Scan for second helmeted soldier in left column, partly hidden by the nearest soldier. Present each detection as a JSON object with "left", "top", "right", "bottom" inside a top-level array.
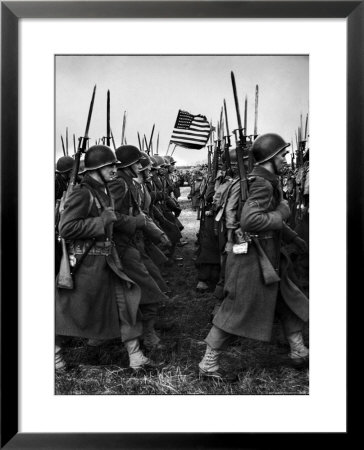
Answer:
[{"left": 110, "top": 145, "right": 169, "bottom": 350}]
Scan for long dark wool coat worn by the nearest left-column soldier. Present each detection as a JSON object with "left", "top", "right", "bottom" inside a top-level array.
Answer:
[{"left": 56, "top": 175, "right": 140, "bottom": 339}]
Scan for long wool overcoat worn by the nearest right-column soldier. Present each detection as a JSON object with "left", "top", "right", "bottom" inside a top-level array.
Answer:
[{"left": 213, "top": 166, "right": 308, "bottom": 341}]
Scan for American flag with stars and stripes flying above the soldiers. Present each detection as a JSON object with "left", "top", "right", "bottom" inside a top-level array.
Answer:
[{"left": 171, "top": 110, "right": 211, "bottom": 150}]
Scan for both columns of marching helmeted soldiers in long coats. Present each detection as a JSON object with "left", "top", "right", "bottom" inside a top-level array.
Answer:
[{"left": 55, "top": 133, "right": 309, "bottom": 381}]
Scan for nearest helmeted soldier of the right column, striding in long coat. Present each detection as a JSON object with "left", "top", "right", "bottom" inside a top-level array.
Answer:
[{"left": 199, "top": 133, "right": 308, "bottom": 381}]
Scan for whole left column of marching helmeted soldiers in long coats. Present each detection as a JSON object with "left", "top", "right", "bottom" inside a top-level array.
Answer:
[{"left": 55, "top": 145, "right": 186, "bottom": 370}]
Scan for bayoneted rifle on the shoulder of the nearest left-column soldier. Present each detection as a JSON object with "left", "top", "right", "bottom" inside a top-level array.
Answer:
[{"left": 57, "top": 85, "right": 96, "bottom": 289}]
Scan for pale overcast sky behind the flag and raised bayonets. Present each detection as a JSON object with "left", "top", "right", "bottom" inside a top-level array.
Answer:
[{"left": 55, "top": 55, "right": 309, "bottom": 165}]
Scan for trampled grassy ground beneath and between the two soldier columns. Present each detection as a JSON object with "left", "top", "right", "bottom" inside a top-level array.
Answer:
[{"left": 55, "top": 187, "right": 309, "bottom": 395}]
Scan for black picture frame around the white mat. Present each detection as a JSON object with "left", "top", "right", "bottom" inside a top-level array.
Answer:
[{"left": 0, "top": 0, "right": 358, "bottom": 449}]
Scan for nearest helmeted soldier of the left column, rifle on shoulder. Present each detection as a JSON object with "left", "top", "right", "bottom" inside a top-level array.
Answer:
[{"left": 56, "top": 145, "right": 154, "bottom": 370}]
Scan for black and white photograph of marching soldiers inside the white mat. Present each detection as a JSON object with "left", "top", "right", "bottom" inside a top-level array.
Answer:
[{"left": 54, "top": 54, "right": 315, "bottom": 396}]
